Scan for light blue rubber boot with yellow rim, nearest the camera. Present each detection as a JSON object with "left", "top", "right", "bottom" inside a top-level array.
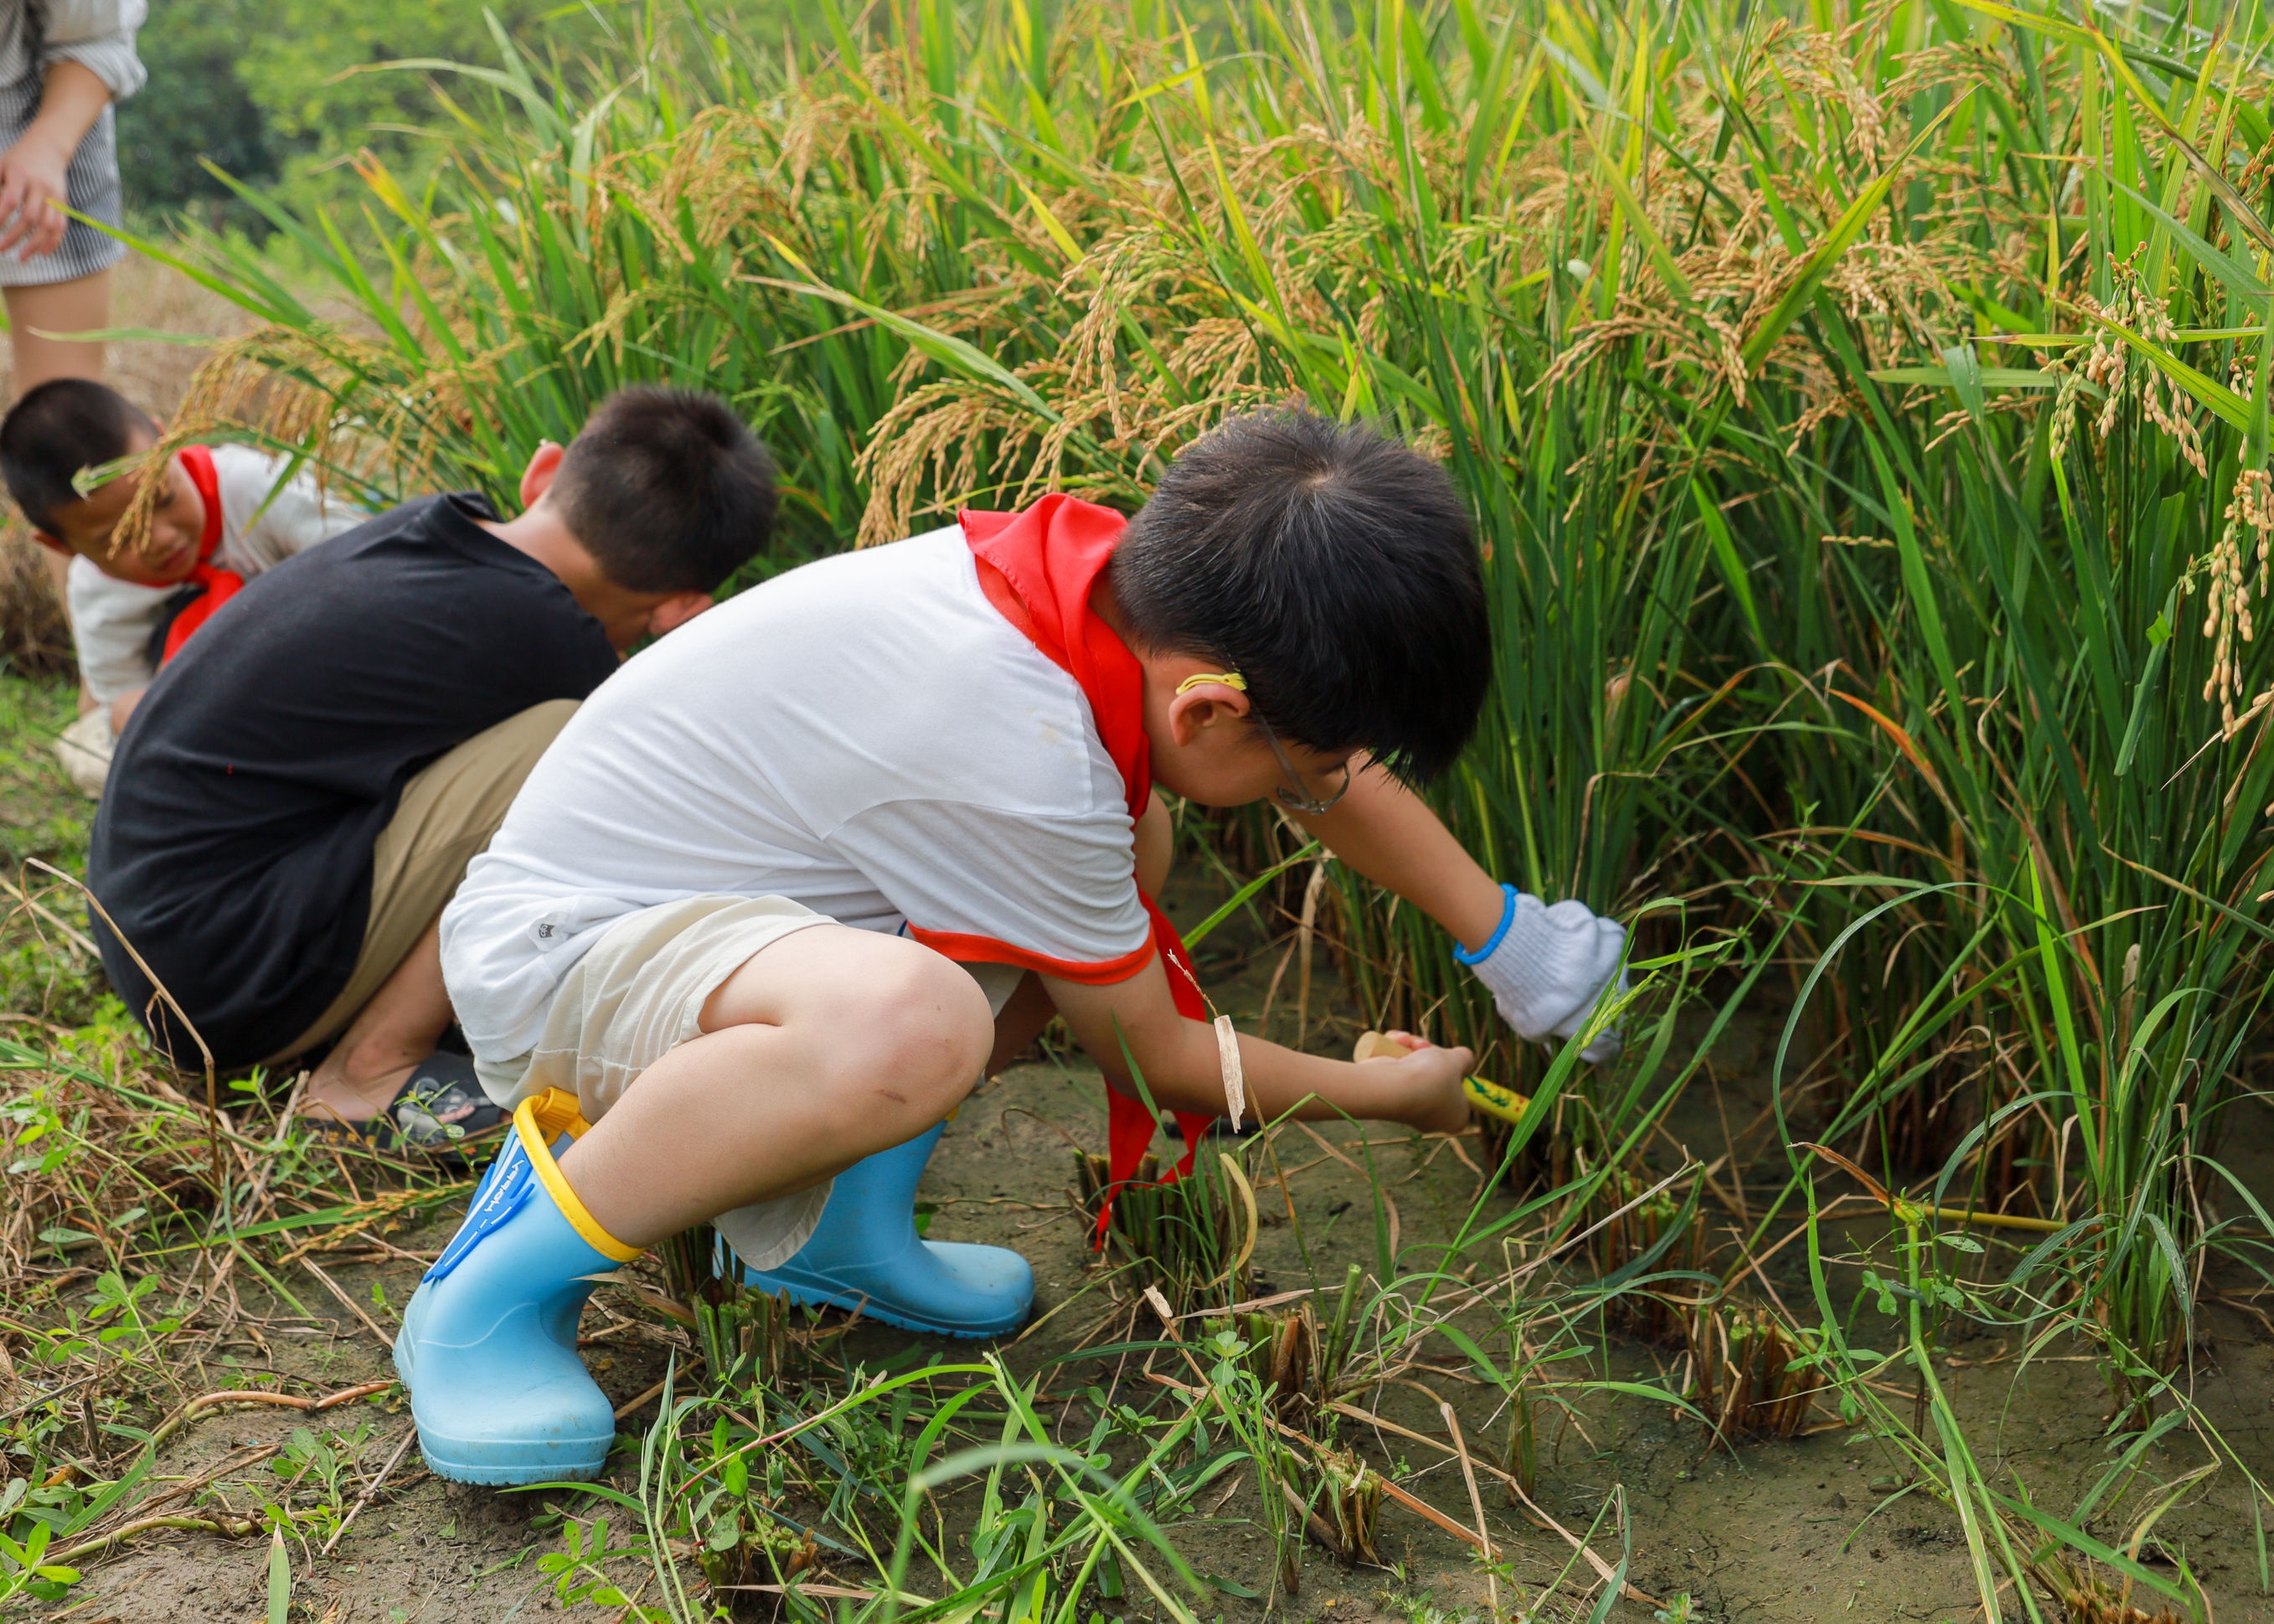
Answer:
[{"left": 395, "top": 1090, "right": 639, "bottom": 1483}]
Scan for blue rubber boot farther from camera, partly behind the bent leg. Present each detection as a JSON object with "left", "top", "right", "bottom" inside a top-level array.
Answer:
[{"left": 744, "top": 1124, "right": 1034, "bottom": 1338}]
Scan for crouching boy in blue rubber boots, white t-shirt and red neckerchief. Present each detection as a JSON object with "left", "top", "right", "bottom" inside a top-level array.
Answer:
[{"left": 395, "top": 412, "right": 1624, "bottom": 1483}]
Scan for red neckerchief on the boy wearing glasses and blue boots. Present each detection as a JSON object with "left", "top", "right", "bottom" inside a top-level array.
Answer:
[{"left": 957, "top": 496, "right": 1214, "bottom": 1246}]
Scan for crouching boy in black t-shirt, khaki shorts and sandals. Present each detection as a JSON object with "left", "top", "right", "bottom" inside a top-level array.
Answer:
[{"left": 86, "top": 389, "right": 773, "bottom": 1148}]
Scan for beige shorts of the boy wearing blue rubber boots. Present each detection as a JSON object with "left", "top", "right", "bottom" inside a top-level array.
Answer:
[{"left": 475, "top": 896, "right": 834, "bottom": 1269}]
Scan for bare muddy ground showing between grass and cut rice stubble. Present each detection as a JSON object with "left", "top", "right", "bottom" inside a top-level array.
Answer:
[{"left": 26, "top": 878, "right": 2274, "bottom": 1624}]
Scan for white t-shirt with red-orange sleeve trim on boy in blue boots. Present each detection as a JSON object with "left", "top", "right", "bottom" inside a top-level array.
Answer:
[{"left": 441, "top": 530, "right": 1153, "bottom": 1062}]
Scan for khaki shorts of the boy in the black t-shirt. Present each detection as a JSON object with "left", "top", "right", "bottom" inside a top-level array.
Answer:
[{"left": 261, "top": 699, "right": 575, "bottom": 1065}]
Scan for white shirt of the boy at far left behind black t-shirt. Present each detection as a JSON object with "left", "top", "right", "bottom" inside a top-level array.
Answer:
[{"left": 66, "top": 446, "right": 371, "bottom": 705}]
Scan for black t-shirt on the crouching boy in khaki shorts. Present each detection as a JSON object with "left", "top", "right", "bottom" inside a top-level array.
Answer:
[{"left": 86, "top": 496, "right": 616, "bottom": 1067}]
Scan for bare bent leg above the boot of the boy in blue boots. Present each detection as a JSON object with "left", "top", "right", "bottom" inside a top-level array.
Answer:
[{"left": 562, "top": 925, "right": 993, "bottom": 1246}]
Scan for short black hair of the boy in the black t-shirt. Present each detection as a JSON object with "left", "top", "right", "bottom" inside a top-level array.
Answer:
[{"left": 548, "top": 387, "right": 773, "bottom": 591}]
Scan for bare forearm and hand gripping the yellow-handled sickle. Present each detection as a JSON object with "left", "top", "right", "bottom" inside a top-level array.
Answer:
[{"left": 1041, "top": 956, "right": 1476, "bottom": 1132}]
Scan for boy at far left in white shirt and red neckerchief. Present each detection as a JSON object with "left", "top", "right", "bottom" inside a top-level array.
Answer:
[{"left": 0, "top": 378, "right": 369, "bottom": 794}]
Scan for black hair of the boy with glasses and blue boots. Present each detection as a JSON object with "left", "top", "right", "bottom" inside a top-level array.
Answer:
[{"left": 1112, "top": 407, "right": 1492, "bottom": 782}]
